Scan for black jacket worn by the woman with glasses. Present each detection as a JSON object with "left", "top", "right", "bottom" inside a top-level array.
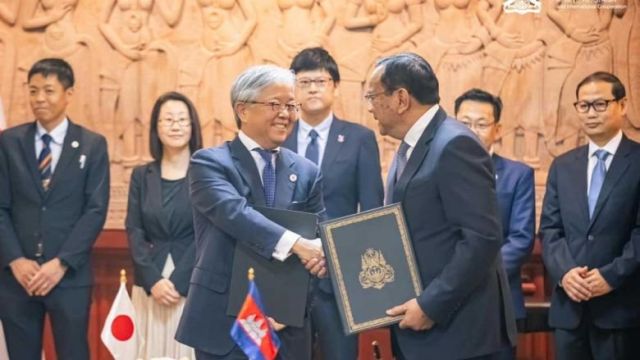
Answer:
[{"left": 126, "top": 162, "right": 195, "bottom": 296}]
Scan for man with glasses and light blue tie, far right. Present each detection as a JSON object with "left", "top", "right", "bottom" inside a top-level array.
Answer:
[{"left": 540, "top": 72, "right": 640, "bottom": 360}]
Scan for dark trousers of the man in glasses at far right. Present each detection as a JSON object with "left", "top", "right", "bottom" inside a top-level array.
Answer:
[{"left": 554, "top": 305, "right": 640, "bottom": 360}]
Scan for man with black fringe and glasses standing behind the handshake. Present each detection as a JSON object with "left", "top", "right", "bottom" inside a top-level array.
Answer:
[{"left": 283, "top": 48, "right": 383, "bottom": 360}]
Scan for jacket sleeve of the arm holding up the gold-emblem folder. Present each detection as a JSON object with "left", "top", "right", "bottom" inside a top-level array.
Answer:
[{"left": 418, "top": 136, "right": 502, "bottom": 326}]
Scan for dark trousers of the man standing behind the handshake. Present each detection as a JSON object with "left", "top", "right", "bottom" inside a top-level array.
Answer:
[{"left": 311, "top": 289, "right": 358, "bottom": 360}]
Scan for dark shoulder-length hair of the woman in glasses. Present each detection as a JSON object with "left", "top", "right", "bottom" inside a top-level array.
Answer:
[{"left": 149, "top": 91, "right": 202, "bottom": 161}]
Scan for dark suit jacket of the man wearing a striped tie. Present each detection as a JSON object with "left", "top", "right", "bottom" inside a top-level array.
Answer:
[{"left": 0, "top": 121, "right": 109, "bottom": 287}]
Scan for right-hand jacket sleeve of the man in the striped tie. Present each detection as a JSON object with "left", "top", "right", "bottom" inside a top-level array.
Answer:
[{"left": 58, "top": 136, "right": 109, "bottom": 270}]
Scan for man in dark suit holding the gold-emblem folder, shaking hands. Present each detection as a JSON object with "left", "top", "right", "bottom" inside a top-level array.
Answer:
[{"left": 365, "top": 53, "right": 515, "bottom": 359}]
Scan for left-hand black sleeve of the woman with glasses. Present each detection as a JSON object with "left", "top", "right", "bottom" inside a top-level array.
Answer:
[{"left": 125, "top": 167, "right": 162, "bottom": 293}]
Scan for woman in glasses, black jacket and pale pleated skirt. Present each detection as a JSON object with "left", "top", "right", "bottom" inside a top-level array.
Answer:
[{"left": 126, "top": 92, "right": 202, "bottom": 359}]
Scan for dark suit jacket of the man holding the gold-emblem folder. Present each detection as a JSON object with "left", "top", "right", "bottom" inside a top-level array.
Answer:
[{"left": 389, "top": 109, "right": 516, "bottom": 359}]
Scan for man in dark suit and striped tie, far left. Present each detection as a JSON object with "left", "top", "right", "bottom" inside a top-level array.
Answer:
[{"left": 0, "top": 59, "right": 109, "bottom": 359}]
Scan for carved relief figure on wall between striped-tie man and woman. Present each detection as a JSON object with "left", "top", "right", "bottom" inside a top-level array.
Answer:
[{"left": 98, "top": 0, "right": 184, "bottom": 168}]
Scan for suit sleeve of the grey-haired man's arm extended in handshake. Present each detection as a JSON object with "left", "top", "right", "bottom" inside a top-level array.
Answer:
[{"left": 189, "top": 150, "right": 285, "bottom": 259}]
